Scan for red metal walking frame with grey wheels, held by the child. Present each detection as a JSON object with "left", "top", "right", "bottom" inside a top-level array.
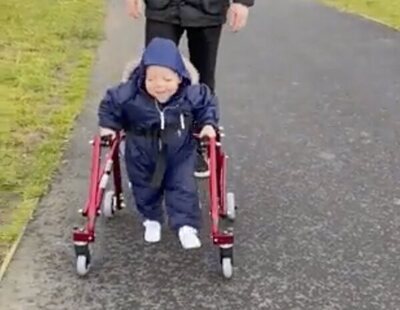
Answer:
[{"left": 73, "top": 128, "right": 236, "bottom": 278}]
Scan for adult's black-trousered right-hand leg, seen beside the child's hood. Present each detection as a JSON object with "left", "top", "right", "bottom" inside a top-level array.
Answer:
[{"left": 186, "top": 26, "right": 222, "bottom": 91}]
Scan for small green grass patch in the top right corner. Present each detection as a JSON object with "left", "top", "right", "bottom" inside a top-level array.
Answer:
[{"left": 321, "top": 0, "right": 400, "bottom": 30}]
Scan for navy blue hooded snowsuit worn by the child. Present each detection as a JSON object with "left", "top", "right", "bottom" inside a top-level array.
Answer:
[{"left": 98, "top": 38, "right": 219, "bottom": 230}]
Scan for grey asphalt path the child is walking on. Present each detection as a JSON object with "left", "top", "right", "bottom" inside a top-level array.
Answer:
[{"left": 0, "top": 0, "right": 400, "bottom": 310}]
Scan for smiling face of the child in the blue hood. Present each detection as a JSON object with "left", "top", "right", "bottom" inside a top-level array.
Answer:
[{"left": 145, "top": 66, "right": 181, "bottom": 103}]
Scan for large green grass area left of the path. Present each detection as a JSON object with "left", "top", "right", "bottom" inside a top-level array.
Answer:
[{"left": 0, "top": 0, "right": 105, "bottom": 261}]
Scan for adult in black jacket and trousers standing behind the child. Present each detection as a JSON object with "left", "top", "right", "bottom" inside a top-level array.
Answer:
[{"left": 126, "top": 0, "right": 254, "bottom": 177}]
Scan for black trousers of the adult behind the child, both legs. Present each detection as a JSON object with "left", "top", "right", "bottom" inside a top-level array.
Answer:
[{"left": 145, "top": 19, "right": 222, "bottom": 91}]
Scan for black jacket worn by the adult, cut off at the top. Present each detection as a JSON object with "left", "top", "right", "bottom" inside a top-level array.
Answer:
[{"left": 144, "top": 0, "right": 254, "bottom": 27}]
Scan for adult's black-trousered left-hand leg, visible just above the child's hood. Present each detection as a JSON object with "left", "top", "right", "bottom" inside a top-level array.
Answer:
[{"left": 145, "top": 19, "right": 184, "bottom": 46}]
